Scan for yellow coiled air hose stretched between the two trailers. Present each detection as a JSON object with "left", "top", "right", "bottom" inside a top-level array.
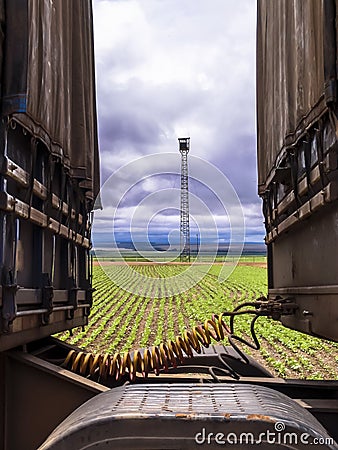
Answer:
[{"left": 62, "top": 297, "right": 268, "bottom": 381}]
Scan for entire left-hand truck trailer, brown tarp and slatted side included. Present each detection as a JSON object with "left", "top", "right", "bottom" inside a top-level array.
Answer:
[{"left": 0, "top": 0, "right": 99, "bottom": 351}]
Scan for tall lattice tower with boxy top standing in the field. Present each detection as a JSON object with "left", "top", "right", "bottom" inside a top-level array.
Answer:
[{"left": 178, "top": 138, "right": 190, "bottom": 262}]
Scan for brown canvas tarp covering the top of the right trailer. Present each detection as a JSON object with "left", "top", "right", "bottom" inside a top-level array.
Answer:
[{"left": 256, "top": 0, "right": 328, "bottom": 192}]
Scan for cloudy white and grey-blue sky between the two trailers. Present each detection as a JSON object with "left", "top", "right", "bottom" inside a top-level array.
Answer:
[{"left": 93, "top": 0, "right": 264, "bottom": 246}]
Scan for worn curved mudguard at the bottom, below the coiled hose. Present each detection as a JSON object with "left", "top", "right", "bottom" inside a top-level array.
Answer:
[{"left": 40, "top": 384, "right": 336, "bottom": 450}]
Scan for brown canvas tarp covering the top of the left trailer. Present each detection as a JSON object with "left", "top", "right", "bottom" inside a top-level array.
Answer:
[{"left": 0, "top": 0, "right": 99, "bottom": 203}]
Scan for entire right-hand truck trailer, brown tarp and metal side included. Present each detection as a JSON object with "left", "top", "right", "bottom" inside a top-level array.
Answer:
[{"left": 257, "top": 0, "right": 338, "bottom": 340}]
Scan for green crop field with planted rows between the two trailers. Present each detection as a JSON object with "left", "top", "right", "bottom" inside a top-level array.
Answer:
[{"left": 60, "top": 259, "right": 338, "bottom": 379}]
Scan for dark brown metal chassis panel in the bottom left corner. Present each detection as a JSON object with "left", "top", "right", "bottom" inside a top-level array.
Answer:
[{"left": 0, "top": 351, "right": 108, "bottom": 450}]
